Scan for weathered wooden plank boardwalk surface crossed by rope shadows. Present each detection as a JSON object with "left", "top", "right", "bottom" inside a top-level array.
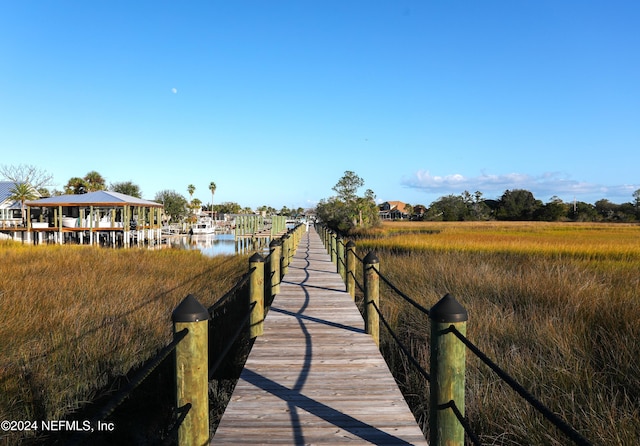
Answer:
[{"left": 211, "top": 228, "right": 427, "bottom": 445}]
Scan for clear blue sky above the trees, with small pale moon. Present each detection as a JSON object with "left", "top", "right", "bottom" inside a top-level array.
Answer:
[{"left": 0, "top": 0, "right": 640, "bottom": 209}]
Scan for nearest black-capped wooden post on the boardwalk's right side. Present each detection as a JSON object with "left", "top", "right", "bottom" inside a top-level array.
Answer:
[{"left": 429, "top": 294, "right": 468, "bottom": 446}]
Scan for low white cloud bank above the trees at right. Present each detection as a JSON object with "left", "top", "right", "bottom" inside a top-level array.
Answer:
[{"left": 402, "top": 170, "right": 640, "bottom": 201}]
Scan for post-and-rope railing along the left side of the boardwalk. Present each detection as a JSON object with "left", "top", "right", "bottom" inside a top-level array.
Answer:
[{"left": 69, "top": 225, "right": 304, "bottom": 446}]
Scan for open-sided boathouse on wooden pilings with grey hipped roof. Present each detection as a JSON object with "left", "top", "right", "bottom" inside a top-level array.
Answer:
[{"left": 25, "top": 191, "right": 163, "bottom": 246}]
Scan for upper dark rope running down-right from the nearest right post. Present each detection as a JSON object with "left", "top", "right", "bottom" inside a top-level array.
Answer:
[{"left": 449, "top": 325, "right": 591, "bottom": 446}]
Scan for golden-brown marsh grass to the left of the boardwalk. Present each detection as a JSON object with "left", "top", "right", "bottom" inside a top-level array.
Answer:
[{"left": 0, "top": 242, "right": 248, "bottom": 442}]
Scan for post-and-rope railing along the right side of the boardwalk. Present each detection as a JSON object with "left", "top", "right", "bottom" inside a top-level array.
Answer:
[{"left": 316, "top": 224, "right": 591, "bottom": 446}]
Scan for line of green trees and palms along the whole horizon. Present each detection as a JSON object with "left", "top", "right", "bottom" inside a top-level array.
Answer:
[{"left": 6, "top": 165, "right": 640, "bottom": 226}]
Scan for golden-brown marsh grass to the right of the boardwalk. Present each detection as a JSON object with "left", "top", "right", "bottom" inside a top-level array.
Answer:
[{"left": 355, "top": 222, "right": 640, "bottom": 445}]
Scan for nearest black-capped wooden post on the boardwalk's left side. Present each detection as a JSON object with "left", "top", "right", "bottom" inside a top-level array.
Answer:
[{"left": 171, "top": 294, "right": 209, "bottom": 446}]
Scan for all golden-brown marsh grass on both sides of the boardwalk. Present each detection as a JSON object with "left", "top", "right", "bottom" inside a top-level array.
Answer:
[{"left": 0, "top": 222, "right": 640, "bottom": 445}]
